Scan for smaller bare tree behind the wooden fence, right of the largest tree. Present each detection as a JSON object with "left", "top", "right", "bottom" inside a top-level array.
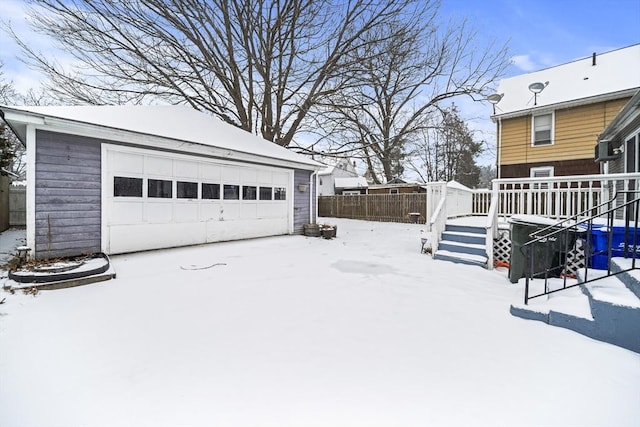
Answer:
[{"left": 306, "top": 0, "right": 508, "bottom": 183}]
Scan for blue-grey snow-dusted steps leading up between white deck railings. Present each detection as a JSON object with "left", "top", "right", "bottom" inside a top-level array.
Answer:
[{"left": 433, "top": 223, "right": 487, "bottom": 267}]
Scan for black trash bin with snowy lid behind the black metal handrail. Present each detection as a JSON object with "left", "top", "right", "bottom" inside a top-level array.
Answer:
[{"left": 509, "top": 217, "right": 576, "bottom": 283}]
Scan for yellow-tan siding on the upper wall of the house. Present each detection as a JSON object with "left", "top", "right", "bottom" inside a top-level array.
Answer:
[{"left": 500, "top": 98, "right": 629, "bottom": 165}]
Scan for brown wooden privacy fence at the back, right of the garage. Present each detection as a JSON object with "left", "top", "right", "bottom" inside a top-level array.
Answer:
[{"left": 318, "top": 193, "right": 427, "bottom": 224}]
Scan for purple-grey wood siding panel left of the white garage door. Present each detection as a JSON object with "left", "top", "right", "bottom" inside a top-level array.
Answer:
[{"left": 35, "top": 130, "right": 101, "bottom": 258}]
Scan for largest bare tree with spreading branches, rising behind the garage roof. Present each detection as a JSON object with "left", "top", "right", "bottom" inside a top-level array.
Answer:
[{"left": 8, "top": 0, "right": 421, "bottom": 146}]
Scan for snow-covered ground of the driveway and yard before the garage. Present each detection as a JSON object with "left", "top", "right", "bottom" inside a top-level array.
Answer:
[{"left": 0, "top": 219, "right": 640, "bottom": 427}]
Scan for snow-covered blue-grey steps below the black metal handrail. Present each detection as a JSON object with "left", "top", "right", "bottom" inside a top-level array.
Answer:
[{"left": 511, "top": 258, "right": 640, "bottom": 353}]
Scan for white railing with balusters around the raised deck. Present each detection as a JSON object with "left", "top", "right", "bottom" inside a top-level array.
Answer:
[{"left": 427, "top": 173, "right": 640, "bottom": 269}]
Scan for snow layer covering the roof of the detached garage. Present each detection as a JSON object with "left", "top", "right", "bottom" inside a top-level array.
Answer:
[{"left": 2, "top": 105, "right": 322, "bottom": 169}]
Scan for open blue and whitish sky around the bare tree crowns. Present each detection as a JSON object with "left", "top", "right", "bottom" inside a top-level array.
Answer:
[{"left": 0, "top": 0, "right": 640, "bottom": 169}]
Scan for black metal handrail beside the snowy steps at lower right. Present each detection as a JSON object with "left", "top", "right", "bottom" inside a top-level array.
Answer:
[{"left": 519, "top": 190, "right": 640, "bottom": 305}]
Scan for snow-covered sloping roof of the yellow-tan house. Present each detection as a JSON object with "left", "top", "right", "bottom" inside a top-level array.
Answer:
[{"left": 496, "top": 44, "right": 640, "bottom": 117}]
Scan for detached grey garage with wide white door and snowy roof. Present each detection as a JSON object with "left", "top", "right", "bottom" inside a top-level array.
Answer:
[{"left": 0, "top": 106, "right": 324, "bottom": 258}]
